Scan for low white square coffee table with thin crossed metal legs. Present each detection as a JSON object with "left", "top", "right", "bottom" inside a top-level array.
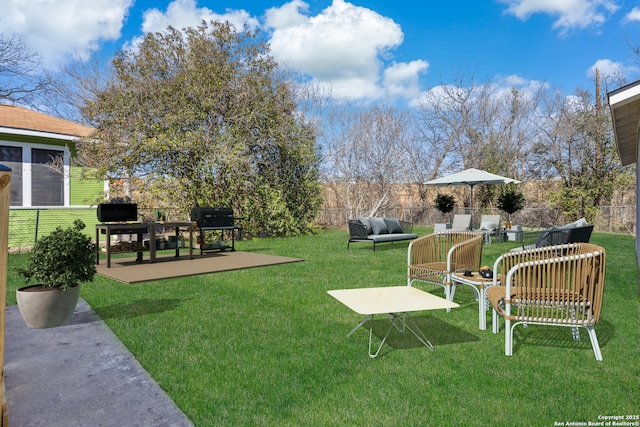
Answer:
[{"left": 327, "top": 286, "right": 459, "bottom": 358}]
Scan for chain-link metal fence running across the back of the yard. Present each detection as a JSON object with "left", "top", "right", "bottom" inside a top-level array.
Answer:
[{"left": 9, "top": 206, "right": 636, "bottom": 252}]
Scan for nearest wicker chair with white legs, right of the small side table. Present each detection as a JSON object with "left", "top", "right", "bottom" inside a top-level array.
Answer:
[{"left": 487, "top": 243, "right": 606, "bottom": 361}]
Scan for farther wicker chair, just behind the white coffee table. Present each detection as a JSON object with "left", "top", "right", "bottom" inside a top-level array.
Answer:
[{"left": 407, "top": 230, "right": 484, "bottom": 308}]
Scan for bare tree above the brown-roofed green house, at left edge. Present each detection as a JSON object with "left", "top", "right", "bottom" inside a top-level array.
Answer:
[{"left": 0, "top": 33, "right": 54, "bottom": 107}]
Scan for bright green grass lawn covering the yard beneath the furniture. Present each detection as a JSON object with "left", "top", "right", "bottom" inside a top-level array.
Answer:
[{"left": 8, "top": 228, "right": 640, "bottom": 426}]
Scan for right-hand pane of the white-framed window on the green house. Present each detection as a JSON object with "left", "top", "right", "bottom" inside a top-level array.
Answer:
[{"left": 31, "top": 148, "right": 64, "bottom": 206}]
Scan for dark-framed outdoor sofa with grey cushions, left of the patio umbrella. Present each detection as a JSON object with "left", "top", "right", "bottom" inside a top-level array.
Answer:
[{"left": 347, "top": 216, "right": 418, "bottom": 252}]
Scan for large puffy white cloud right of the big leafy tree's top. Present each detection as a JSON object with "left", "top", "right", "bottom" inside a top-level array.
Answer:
[{"left": 265, "top": 0, "right": 428, "bottom": 99}]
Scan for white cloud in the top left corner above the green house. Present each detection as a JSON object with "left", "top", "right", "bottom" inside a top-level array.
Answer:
[{"left": 0, "top": 0, "right": 133, "bottom": 69}]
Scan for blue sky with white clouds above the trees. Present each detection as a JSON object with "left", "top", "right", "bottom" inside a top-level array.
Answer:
[{"left": 0, "top": 0, "right": 640, "bottom": 105}]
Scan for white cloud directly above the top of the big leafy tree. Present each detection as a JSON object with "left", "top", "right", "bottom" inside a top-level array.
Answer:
[{"left": 142, "top": 0, "right": 258, "bottom": 34}]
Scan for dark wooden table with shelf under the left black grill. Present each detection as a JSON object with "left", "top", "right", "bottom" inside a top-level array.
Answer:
[{"left": 96, "top": 222, "right": 193, "bottom": 268}]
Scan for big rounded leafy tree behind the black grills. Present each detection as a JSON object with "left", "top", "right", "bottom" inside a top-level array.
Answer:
[{"left": 79, "top": 22, "right": 321, "bottom": 235}]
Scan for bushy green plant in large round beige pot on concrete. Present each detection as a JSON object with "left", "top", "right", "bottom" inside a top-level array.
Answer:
[{"left": 16, "top": 219, "right": 96, "bottom": 328}]
